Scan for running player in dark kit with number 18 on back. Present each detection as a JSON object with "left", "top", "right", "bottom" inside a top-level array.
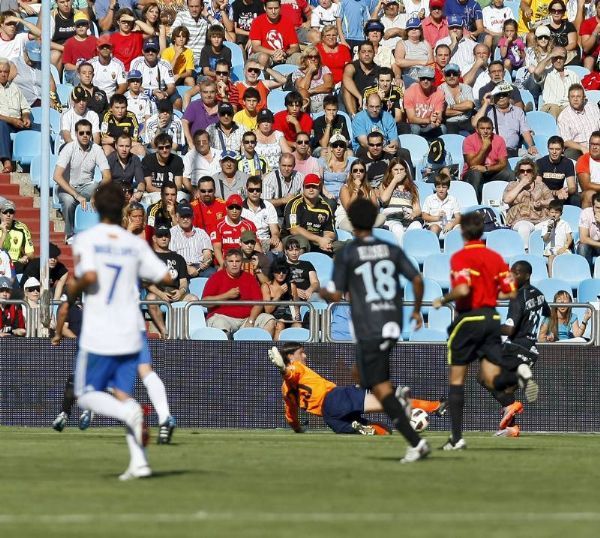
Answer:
[{"left": 320, "top": 198, "right": 431, "bottom": 463}]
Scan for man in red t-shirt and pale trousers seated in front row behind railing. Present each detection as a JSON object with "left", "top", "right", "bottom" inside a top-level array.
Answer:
[{"left": 202, "top": 248, "right": 276, "bottom": 336}]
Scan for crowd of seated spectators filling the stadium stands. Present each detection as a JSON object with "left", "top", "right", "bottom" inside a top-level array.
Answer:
[{"left": 0, "top": 0, "right": 600, "bottom": 338}]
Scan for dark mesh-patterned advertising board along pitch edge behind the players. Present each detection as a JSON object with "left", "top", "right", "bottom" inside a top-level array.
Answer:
[{"left": 0, "top": 340, "right": 600, "bottom": 435}]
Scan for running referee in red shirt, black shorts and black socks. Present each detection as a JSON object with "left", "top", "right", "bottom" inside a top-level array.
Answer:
[{"left": 433, "top": 212, "right": 537, "bottom": 450}]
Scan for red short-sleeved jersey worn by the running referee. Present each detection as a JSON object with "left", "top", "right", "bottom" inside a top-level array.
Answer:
[{"left": 450, "top": 241, "right": 516, "bottom": 312}]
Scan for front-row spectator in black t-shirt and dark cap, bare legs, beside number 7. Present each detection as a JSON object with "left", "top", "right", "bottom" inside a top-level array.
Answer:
[{"left": 146, "top": 225, "right": 198, "bottom": 338}]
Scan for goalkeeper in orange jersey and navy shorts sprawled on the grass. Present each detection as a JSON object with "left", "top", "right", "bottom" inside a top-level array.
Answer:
[{"left": 269, "top": 342, "right": 446, "bottom": 435}]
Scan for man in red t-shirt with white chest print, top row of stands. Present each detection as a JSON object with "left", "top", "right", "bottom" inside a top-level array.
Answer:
[{"left": 249, "top": 0, "right": 300, "bottom": 66}]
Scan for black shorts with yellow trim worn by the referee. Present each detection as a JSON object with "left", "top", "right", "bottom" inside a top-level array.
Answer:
[{"left": 448, "top": 308, "right": 502, "bottom": 366}]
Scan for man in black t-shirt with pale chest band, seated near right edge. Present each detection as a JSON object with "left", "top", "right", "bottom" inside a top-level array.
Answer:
[{"left": 536, "top": 135, "right": 581, "bottom": 207}]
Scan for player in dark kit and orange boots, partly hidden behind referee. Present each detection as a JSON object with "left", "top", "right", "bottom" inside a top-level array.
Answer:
[{"left": 492, "top": 260, "right": 550, "bottom": 437}]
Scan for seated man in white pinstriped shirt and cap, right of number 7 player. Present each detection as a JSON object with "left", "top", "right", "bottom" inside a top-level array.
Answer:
[{"left": 169, "top": 202, "right": 215, "bottom": 278}]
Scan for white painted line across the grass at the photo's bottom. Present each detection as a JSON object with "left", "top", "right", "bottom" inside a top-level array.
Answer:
[{"left": 0, "top": 511, "right": 600, "bottom": 525}]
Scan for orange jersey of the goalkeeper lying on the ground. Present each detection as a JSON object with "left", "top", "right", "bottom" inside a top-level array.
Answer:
[{"left": 281, "top": 362, "right": 336, "bottom": 427}]
